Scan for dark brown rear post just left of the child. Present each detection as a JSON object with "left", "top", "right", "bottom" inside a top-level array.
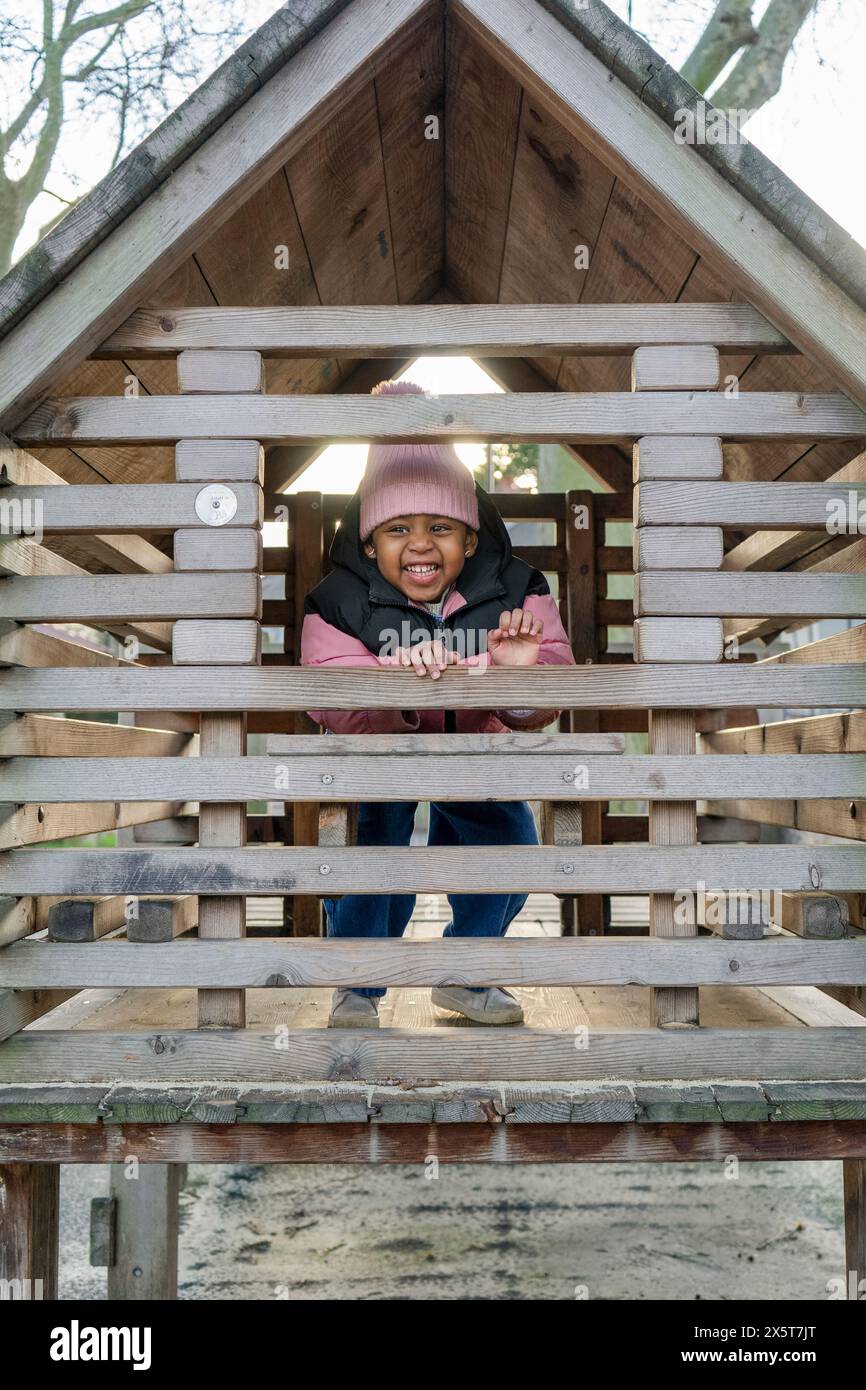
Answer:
[{"left": 289, "top": 492, "right": 324, "bottom": 937}]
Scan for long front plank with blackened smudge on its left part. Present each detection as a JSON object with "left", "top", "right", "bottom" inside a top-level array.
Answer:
[{"left": 0, "top": 845, "right": 866, "bottom": 897}]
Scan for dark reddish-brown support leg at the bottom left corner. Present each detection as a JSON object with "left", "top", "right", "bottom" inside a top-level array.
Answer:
[{"left": 0, "top": 1163, "right": 60, "bottom": 1300}]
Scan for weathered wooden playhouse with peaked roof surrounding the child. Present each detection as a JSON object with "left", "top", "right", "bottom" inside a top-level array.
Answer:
[{"left": 0, "top": 0, "right": 866, "bottom": 1298}]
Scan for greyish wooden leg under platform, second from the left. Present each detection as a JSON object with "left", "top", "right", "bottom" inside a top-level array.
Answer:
[{"left": 108, "top": 1163, "right": 179, "bottom": 1302}]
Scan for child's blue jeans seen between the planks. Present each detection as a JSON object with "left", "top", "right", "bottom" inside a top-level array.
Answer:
[{"left": 322, "top": 801, "right": 538, "bottom": 997}]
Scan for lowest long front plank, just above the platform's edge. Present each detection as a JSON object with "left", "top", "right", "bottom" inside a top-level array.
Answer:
[{"left": 0, "top": 1027, "right": 866, "bottom": 1083}]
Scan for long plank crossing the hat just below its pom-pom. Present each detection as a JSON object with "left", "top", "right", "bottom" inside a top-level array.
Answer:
[{"left": 15, "top": 391, "right": 866, "bottom": 444}]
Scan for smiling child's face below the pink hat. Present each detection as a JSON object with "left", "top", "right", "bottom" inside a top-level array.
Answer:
[{"left": 364, "top": 513, "right": 478, "bottom": 602}]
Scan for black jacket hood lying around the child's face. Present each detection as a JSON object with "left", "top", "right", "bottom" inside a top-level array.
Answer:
[{"left": 328, "top": 482, "right": 512, "bottom": 603}]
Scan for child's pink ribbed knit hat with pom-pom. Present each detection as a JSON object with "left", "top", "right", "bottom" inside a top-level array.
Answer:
[{"left": 359, "top": 381, "right": 478, "bottom": 541}]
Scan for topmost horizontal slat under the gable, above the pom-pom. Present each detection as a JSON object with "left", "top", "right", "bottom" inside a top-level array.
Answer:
[{"left": 90, "top": 303, "right": 792, "bottom": 359}]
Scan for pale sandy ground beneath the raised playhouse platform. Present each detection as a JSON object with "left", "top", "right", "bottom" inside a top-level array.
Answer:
[{"left": 60, "top": 1162, "right": 844, "bottom": 1301}]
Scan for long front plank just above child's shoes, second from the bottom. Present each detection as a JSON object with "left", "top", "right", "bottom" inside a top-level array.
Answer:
[{"left": 0, "top": 934, "right": 866, "bottom": 990}]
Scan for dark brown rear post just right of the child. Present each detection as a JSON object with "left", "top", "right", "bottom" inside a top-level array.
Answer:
[{"left": 563, "top": 489, "right": 605, "bottom": 937}]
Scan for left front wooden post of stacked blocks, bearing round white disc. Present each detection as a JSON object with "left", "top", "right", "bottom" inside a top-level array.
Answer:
[{"left": 172, "top": 350, "right": 264, "bottom": 1029}]
